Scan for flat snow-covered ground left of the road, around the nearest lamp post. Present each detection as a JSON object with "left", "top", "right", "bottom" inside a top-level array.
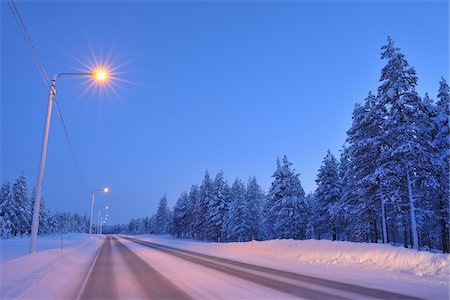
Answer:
[{"left": 0, "top": 234, "right": 103, "bottom": 299}]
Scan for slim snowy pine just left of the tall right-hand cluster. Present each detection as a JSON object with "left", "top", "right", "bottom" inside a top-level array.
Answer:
[{"left": 315, "top": 150, "right": 341, "bottom": 241}]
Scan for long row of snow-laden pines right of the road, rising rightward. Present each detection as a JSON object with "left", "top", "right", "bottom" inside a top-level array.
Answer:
[{"left": 118, "top": 37, "right": 450, "bottom": 253}]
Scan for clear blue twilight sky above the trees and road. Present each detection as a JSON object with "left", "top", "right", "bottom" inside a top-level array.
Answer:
[{"left": 1, "top": 1, "right": 449, "bottom": 223}]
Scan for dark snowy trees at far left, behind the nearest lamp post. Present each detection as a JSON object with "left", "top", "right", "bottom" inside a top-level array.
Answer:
[{"left": 0, "top": 176, "right": 89, "bottom": 238}]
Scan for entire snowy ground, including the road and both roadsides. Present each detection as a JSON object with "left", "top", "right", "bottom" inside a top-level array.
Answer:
[{"left": 0, "top": 235, "right": 449, "bottom": 299}]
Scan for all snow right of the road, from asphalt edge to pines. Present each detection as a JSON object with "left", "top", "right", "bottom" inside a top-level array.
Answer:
[{"left": 133, "top": 235, "right": 450, "bottom": 299}]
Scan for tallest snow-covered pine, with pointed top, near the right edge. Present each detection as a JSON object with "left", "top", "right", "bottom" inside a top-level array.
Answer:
[{"left": 378, "top": 38, "right": 433, "bottom": 249}]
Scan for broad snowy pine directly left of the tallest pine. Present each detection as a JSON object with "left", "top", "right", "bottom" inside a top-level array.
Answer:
[{"left": 340, "top": 92, "right": 387, "bottom": 243}]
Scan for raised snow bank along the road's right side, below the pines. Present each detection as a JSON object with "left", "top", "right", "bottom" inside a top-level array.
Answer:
[{"left": 139, "top": 235, "right": 450, "bottom": 278}]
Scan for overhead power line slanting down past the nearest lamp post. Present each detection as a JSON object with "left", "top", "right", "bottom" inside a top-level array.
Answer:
[{"left": 8, "top": 0, "right": 92, "bottom": 191}]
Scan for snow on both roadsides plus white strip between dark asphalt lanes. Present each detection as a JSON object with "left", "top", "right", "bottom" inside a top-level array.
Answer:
[{"left": 0, "top": 234, "right": 450, "bottom": 299}]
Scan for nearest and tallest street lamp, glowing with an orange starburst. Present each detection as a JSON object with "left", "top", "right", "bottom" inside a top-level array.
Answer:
[{"left": 30, "top": 69, "right": 108, "bottom": 253}]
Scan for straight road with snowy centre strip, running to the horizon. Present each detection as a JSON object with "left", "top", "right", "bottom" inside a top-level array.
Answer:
[{"left": 78, "top": 235, "right": 414, "bottom": 299}]
